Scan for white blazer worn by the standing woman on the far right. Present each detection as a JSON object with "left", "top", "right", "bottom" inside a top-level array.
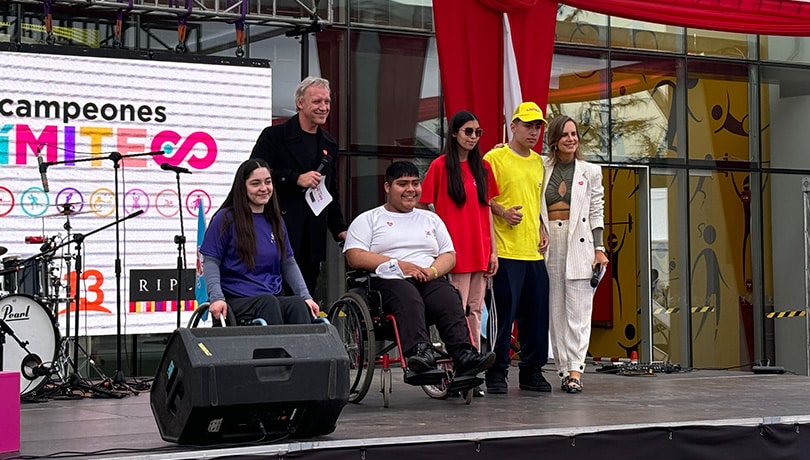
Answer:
[{"left": 540, "top": 155, "right": 605, "bottom": 279}]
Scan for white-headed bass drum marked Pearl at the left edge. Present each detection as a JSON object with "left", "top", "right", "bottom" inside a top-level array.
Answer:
[{"left": 0, "top": 294, "right": 59, "bottom": 396}]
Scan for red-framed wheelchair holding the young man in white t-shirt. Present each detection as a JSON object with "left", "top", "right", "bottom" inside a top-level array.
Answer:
[{"left": 327, "top": 271, "right": 483, "bottom": 408}]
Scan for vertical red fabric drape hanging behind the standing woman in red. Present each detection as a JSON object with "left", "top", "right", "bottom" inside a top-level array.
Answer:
[{"left": 433, "top": 0, "right": 557, "bottom": 147}]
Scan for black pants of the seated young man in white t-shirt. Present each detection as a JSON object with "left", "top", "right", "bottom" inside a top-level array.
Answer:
[{"left": 371, "top": 278, "right": 472, "bottom": 357}]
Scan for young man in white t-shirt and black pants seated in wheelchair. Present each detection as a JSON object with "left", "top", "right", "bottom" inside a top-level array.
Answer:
[{"left": 343, "top": 161, "right": 495, "bottom": 385}]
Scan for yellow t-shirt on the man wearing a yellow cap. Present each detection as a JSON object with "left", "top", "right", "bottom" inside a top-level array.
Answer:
[{"left": 484, "top": 145, "right": 545, "bottom": 260}]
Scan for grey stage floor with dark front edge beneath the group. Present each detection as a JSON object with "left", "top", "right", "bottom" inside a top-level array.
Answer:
[{"left": 0, "top": 366, "right": 810, "bottom": 460}]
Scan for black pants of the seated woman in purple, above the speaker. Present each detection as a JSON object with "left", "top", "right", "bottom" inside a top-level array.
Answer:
[{"left": 227, "top": 294, "right": 312, "bottom": 324}]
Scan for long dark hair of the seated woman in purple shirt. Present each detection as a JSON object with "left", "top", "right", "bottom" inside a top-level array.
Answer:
[{"left": 214, "top": 158, "right": 287, "bottom": 269}]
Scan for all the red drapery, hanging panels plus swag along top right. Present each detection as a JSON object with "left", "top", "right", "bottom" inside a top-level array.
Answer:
[{"left": 433, "top": 0, "right": 810, "bottom": 144}]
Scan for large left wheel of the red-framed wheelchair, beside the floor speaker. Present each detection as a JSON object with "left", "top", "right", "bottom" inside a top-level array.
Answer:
[{"left": 328, "top": 291, "right": 377, "bottom": 403}]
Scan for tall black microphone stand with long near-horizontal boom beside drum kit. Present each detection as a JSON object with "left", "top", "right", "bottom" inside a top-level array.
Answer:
[{"left": 40, "top": 150, "right": 163, "bottom": 384}]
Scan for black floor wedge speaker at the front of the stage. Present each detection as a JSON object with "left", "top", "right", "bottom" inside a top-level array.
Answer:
[{"left": 150, "top": 324, "right": 349, "bottom": 445}]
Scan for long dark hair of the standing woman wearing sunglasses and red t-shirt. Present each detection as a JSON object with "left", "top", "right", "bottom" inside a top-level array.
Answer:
[{"left": 444, "top": 110, "right": 489, "bottom": 208}]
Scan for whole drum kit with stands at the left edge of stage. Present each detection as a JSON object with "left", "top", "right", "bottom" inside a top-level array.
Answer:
[{"left": 0, "top": 203, "right": 109, "bottom": 397}]
